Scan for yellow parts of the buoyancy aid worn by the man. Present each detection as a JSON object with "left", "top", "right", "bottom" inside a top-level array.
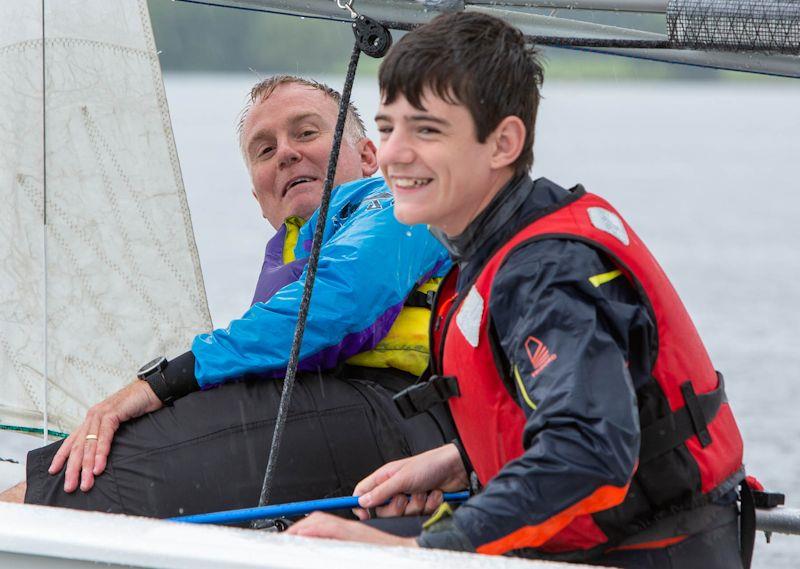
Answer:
[{"left": 283, "top": 216, "right": 442, "bottom": 376}]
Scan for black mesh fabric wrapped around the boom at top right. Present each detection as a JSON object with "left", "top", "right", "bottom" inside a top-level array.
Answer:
[{"left": 667, "top": 0, "right": 800, "bottom": 54}]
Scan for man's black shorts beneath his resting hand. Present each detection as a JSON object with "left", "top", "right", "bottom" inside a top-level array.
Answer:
[{"left": 25, "top": 366, "right": 455, "bottom": 518}]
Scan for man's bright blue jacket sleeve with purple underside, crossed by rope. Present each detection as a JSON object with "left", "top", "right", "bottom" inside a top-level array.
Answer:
[{"left": 192, "top": 186, "right": 447, "bottom": 388}]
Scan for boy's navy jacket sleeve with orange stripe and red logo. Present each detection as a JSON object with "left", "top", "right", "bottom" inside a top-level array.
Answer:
[{"left": 420, "top": 240, "right": 639, "bottom": 554}]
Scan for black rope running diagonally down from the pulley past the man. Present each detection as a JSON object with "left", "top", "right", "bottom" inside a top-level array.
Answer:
[{"left": 251, "top": 43, "right": 361, "bottom": 528}]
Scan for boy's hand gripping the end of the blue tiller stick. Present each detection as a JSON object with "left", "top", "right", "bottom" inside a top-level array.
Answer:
[{"left": 353, "top": 444, "right": 469, "bottom": 520}]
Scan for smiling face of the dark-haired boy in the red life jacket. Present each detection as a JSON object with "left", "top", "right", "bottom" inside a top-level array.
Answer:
[{"left": 375, "top": 91, "right": 497, "bottom": 237}]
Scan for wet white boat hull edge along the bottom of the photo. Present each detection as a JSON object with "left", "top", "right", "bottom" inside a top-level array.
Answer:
[{"left": 0, "top": 503, "right": 592, "bottom": 569}]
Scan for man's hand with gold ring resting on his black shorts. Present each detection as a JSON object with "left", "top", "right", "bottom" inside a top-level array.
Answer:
[{"left": 47, "top": 379, "right": 164, "bottom": 492}]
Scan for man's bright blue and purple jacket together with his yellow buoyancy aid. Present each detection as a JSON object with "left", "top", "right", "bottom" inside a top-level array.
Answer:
[{"left": 192, "top": 178, "right": 450, "bottom": 387}]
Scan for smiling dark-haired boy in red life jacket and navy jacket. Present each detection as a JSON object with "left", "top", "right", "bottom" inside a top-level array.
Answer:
[{"left": 290, "top": 13, "right": 743, "bottom": 569}]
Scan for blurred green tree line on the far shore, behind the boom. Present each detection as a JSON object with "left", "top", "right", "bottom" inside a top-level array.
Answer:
[{"left": 148, "top": 0, "right": 719, "bottom": 79}]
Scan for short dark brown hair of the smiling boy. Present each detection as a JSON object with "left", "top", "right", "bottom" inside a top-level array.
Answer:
[{"left": 378, "top": 12, "right": 544, "bottom": 173}]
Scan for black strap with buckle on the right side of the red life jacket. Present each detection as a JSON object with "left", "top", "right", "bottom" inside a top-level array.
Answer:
[{"left": 639, "top": 372, "right": 727, "bottom": 464}]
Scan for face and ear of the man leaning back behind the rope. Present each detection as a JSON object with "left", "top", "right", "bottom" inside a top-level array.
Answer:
[{"left": 242, "top": 83, "right": 377, "bottom": 228}]
